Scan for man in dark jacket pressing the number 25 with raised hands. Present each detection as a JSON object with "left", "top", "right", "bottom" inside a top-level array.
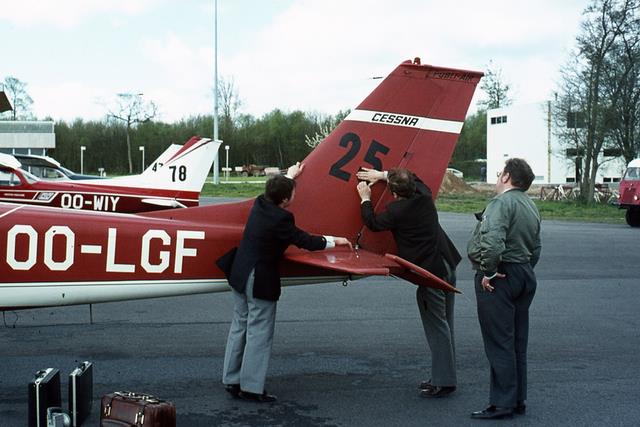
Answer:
[{"left": 357, "top": 169, "right": 461, "bottom": 398}]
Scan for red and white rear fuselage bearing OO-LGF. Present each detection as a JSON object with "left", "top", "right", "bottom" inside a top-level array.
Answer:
[{"left": 0, "top": 201, "right": 344, "bottom": 310}]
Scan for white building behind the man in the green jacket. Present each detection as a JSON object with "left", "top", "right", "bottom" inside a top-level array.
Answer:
[{"left": 487, "top": 102, "right": 626, "bottom": 184}]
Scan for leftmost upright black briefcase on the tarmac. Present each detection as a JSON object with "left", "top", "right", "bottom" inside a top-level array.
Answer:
[{"left": 29, "top": 368, "right": 60, "bottom": 427}]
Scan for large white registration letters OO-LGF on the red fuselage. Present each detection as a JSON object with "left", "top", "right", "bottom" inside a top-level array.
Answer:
[{"left": 5, "top": 224, "right": 205, "bottom": 274}]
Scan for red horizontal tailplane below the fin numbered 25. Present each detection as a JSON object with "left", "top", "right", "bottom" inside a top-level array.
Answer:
[{"left": 285, "top": 248, "right": 462, "bottom": 293}]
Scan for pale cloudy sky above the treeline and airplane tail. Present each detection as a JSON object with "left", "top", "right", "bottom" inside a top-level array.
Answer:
[{"left": 0, "top": 0, "right": 588, "bottom": 122}]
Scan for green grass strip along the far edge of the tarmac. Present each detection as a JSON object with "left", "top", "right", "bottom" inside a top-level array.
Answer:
[{"left": 202, "top": 182, "right": 626, "bottom": 224}]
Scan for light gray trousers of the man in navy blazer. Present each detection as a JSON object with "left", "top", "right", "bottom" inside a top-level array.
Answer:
[{"left": 222, "top": 271, "right": 277, "bottom": 394}]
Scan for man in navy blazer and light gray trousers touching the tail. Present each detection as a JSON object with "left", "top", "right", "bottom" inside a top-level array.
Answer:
[{"left": 222, "top": 163, "right": 351, "bottom": 402}]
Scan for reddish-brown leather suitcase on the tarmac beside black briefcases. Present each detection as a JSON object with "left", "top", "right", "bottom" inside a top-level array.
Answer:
[{"left": 100, "top": 391, "right": 176, "bottom": 427}]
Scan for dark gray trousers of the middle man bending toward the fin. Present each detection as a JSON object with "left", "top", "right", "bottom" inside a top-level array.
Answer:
[{"left": 416, "top": 263, "right": 457, "bottom": 387}]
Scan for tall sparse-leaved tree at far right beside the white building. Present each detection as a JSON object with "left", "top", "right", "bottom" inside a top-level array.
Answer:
[{"left": 554, "top": 0, "right": 639, "bottom": 203}]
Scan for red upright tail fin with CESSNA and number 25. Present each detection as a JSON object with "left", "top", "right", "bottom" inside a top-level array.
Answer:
[{"left": 289, "top": 60, "right": 482, "bottom": 254}]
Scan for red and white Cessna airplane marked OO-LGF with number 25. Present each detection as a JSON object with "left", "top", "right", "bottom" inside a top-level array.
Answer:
[{"left": 0, "top": 59, "right": 482, "bottom": 310}]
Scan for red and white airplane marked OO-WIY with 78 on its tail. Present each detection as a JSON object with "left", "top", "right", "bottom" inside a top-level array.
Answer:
[{"left": 0, "top": 137, "right": 220, "bottom": 213}]
